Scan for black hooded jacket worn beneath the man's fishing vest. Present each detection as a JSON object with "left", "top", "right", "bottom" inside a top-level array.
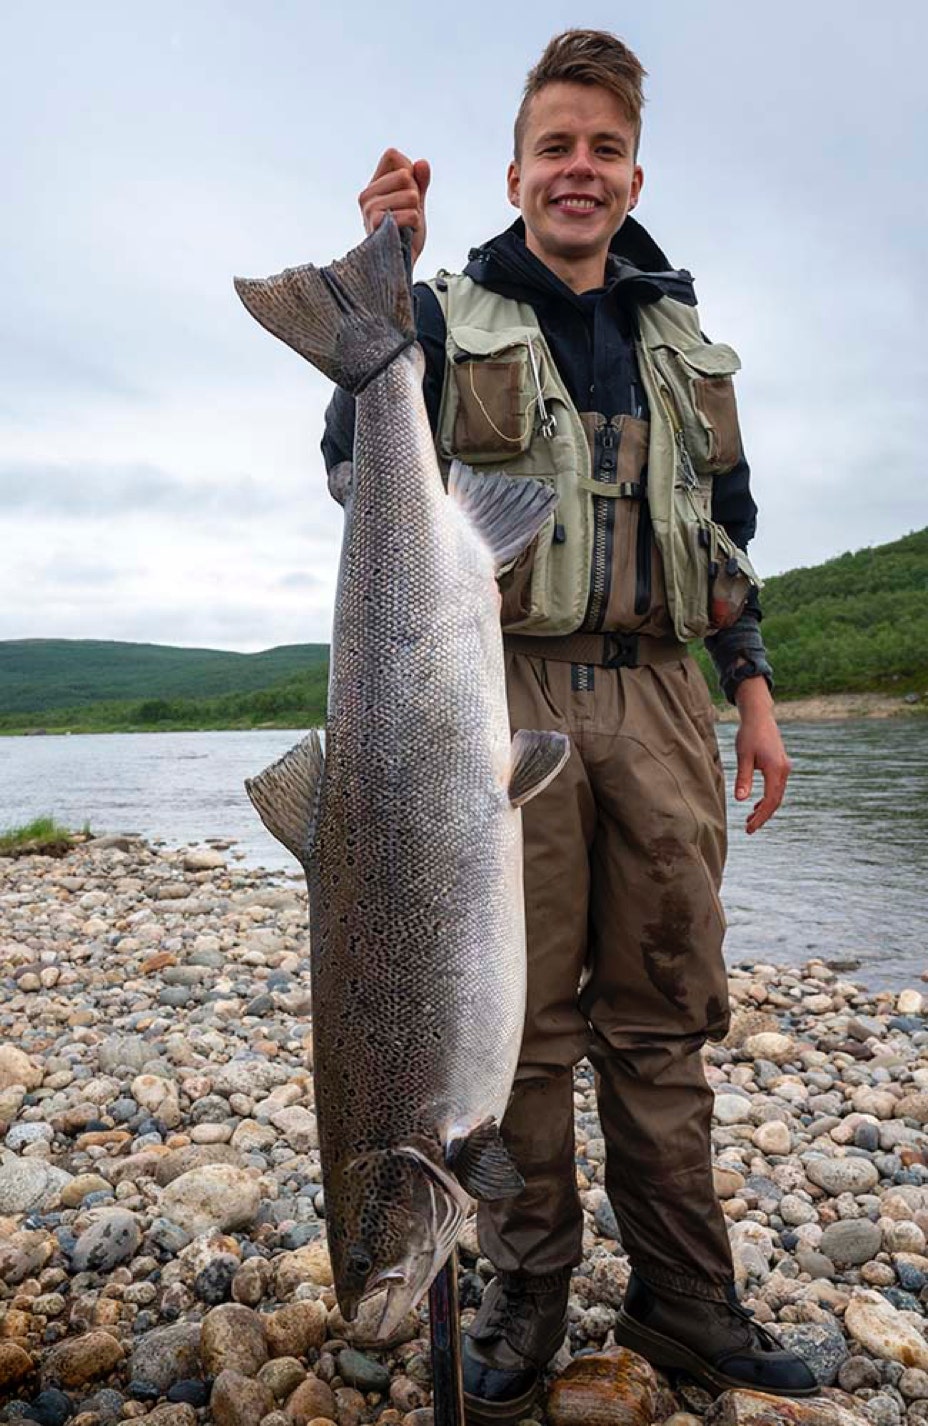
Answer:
[{"left": 322, "top": 218, "right": 770, "bottom": 700}]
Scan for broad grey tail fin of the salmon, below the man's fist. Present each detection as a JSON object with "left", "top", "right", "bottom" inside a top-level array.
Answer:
[{"left": 235, "top": 214, "right": 416, "bottom": 395}]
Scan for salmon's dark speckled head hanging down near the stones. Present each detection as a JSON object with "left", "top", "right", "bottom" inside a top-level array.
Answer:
[{"left": 329, "top": 1147, "right": 469, "bottom": 1339}]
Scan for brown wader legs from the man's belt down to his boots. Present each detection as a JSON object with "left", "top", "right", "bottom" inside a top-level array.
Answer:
[{"left": 479, "top": 635, "right": 733, "bottom": 1299}]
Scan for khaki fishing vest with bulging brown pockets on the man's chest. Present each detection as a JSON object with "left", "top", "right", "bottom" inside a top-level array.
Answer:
[{"left": 428, "top": 272, "right": 760, "bottom": 640}]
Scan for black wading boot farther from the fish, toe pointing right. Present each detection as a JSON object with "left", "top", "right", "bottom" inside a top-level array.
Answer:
[{"left": 616, "top": 1272, "right": 818, "bottom": 1396}]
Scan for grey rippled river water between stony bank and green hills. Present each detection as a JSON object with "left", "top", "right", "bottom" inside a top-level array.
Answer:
[{"left": 0, "top": 719, "right": 928, "bottom": 988}]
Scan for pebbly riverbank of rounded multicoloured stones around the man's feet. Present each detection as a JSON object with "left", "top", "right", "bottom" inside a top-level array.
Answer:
[{"left": 0, "top": 837, "right": 928, "bottom": 1426}]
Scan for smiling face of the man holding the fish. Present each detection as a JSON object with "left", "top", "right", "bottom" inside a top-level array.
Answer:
[{"left": 507, "top": 81, "right": 644, "bottom": 287}]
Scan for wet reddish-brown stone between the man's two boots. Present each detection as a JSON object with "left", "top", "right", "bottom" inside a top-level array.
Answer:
[{"left": 547, "top": 1348, "right": 659, "bottom": 1426}]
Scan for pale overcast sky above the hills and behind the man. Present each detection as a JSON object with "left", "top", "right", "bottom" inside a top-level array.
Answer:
[{"left": 0, "top": 0, "right": 928, "bottom": 650}]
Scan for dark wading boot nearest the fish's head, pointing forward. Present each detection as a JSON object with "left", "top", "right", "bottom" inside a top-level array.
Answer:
[{"left": 462, "top": 1271, "right": 570, "bottom": 1426}]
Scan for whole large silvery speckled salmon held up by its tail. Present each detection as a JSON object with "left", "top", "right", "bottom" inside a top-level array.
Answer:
[{"left": 235, "top": 218, "right": 567, "bottom": 1336}]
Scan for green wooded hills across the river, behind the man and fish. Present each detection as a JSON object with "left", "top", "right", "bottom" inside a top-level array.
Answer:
[{"left": 0, "top": 528, "right": 928, "bottom": 733}]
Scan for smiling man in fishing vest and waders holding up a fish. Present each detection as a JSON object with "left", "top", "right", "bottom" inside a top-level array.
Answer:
[{"left": 324, "top": 30, "right": 815, "bottom": 1423}]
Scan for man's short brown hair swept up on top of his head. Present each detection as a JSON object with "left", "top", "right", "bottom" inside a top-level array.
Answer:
[{"left": 513, "top": 30, "right": 647, "bottom": 163}]
